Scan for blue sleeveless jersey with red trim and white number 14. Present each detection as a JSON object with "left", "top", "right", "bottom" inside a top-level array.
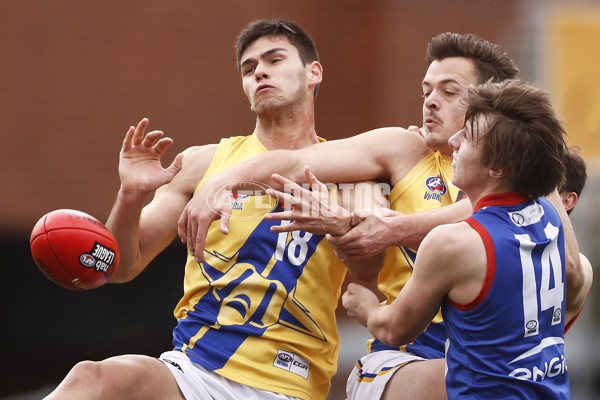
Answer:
[{"left": 442, "top": 193, "right": 570, "bottom": 399}]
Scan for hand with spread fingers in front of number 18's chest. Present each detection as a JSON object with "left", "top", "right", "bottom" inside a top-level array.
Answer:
[{"left": 265, "top": 166, "right": 351, "bottom": 235}]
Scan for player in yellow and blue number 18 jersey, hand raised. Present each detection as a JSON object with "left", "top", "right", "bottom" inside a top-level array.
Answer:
[{"left": 48, "top": 20, "right": 384, "bottom": 400}]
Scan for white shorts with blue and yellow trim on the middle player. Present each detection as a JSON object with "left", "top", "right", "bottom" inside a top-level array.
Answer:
[{"left": 346, "top": 350, "right": 426, "bottom": 400}]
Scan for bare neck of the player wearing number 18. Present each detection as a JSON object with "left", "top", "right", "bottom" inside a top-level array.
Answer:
[{"left": 255, "top": 100, "right": 319, "bottom": 150}]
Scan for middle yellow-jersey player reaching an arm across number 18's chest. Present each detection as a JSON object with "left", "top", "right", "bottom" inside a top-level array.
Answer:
[{"left": 179, "top": 33, "right": 581, "bottom": 400}]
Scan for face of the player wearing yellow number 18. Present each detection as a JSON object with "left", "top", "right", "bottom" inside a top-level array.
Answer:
[{"left": 240, "top": 36, "right": 312, "bottom": 115}]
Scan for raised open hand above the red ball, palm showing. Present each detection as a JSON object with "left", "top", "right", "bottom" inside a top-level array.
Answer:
[{"left": 119, "top": 118, "right": 183, "bottom": 193}]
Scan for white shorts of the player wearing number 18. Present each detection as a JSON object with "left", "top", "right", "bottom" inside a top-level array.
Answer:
[{"left": 158, "top": 351, "right": 300, "bottom": 400}]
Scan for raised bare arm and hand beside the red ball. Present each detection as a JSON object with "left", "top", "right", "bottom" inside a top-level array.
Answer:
[{"left": 106, "top": 119, "right": 212, "bottom": 283}]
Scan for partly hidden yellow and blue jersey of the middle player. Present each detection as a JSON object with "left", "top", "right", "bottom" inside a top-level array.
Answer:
[{"left": 369, "top": 152, "right": 460, "bottom": 359}]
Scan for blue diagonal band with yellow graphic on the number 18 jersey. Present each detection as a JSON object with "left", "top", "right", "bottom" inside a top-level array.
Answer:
[{"left": 173, "top": 205, "right": 326, "bottom": 369}]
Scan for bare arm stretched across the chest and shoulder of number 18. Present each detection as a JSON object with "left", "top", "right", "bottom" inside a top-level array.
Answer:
[{"left": 178, "top": 128, "right": 428, "bottom": 261}]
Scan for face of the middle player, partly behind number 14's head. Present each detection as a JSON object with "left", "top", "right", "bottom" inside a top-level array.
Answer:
[{"left": 423, "top": 57, "right": 477, "bottom": 156}]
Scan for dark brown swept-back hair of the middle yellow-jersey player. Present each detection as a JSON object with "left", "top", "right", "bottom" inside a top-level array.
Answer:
[{"left": 427, "top": 32, "right": 519, "bottom": 83}]
